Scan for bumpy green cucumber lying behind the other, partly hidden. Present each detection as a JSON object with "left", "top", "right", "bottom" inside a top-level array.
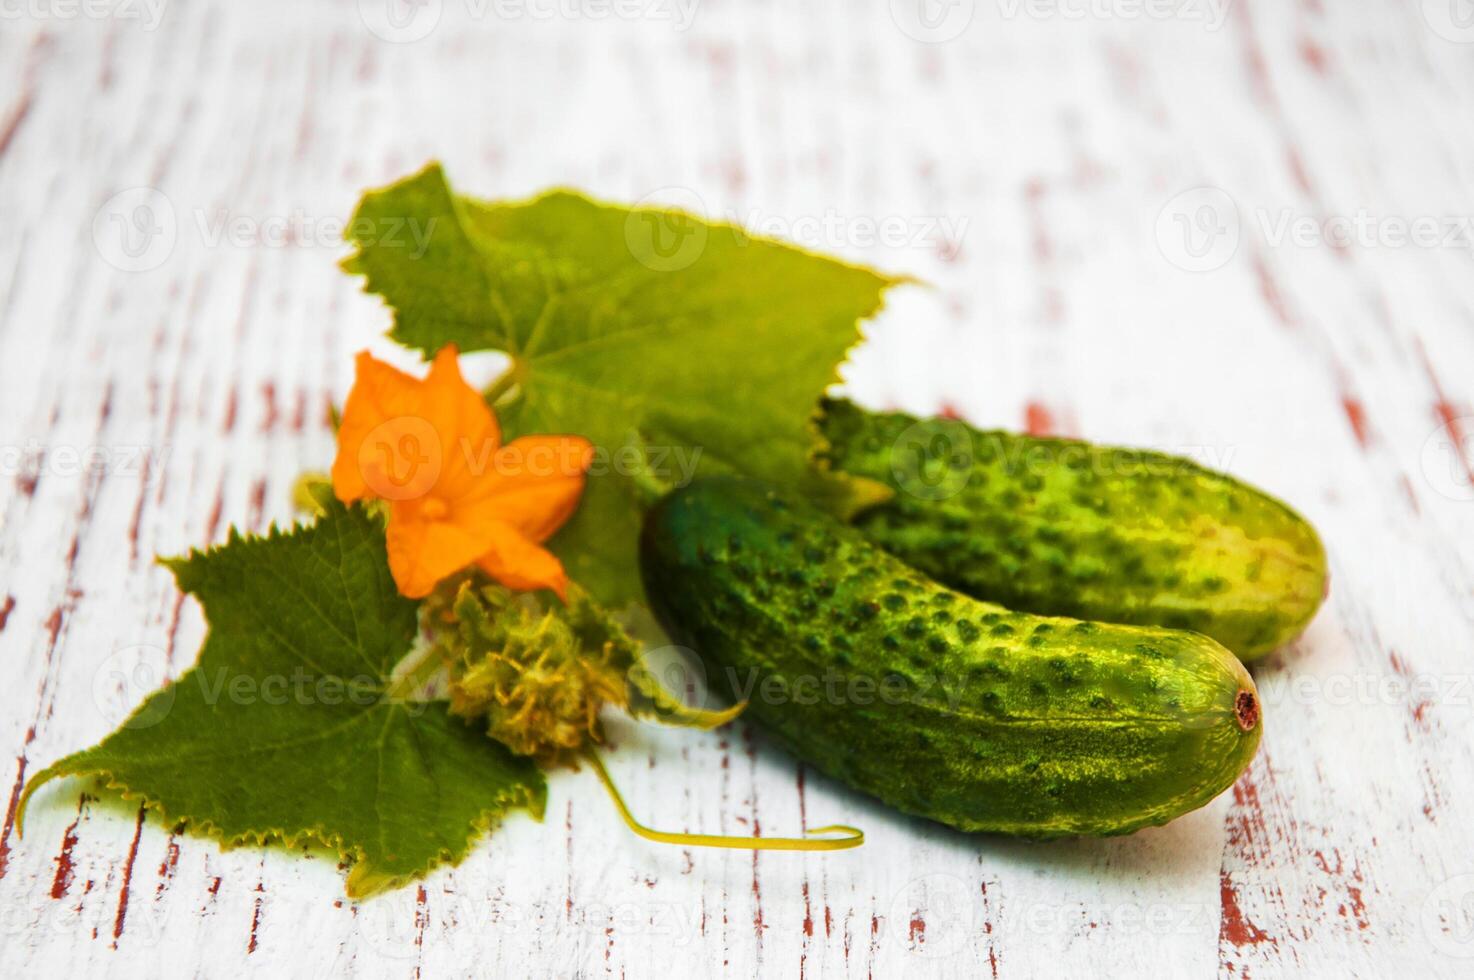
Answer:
[{"left": 820, "top": 401, "right": 1327, "bottom": 660}]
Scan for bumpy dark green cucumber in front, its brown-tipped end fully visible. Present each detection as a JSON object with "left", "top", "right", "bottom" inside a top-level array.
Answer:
[{"left": 641, "top": 477, "right": 1262, "bottom": 837}]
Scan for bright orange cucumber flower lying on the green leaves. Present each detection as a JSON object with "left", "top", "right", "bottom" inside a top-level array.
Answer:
[{"left": 333, "top": 346, "right": 593, "bottom": 598}]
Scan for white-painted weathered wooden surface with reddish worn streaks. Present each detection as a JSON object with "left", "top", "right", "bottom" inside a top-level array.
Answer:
[{"left": 0, "top": 0, "right": 1474, "bottom": 979}]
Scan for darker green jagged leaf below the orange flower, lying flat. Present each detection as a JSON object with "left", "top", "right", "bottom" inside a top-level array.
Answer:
[{"left": 21, "top": 498, "right": 545, "bottom": 896}]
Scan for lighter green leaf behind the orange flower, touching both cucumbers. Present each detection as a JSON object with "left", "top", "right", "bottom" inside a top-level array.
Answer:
[{"left": 343, "top": 164, "right": 901, "bottom": 604}]
